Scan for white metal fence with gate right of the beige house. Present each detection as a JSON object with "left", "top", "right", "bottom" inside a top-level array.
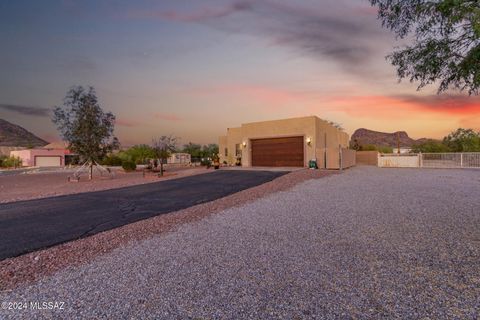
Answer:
[{"left": 378, "top": 152, "right": 480, "bottom": 168}]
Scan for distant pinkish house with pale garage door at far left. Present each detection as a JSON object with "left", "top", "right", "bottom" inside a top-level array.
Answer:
[{"left": 10, "top": 143, "right": 72, "bottom": 167}]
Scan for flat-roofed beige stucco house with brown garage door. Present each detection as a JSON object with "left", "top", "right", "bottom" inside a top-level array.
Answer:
[{"left": 219, "top": 116, "right": 355, "bottom": 169}]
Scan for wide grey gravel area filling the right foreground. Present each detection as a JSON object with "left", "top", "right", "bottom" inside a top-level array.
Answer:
[{"left": 0, "top": 167, "right": 480, "bottom": 319}]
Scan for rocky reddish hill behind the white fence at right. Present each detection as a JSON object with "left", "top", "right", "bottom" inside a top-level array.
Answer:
[{"left": 351, "top": 128, "right": 428, "bottom": 148}]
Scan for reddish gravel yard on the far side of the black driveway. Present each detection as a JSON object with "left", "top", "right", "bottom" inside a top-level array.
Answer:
[{"left": 0, "top": 166, "right": 209, "bottom": 203}]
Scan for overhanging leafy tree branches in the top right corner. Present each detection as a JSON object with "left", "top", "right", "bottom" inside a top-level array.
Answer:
[{"left": 370, "top": 0, "right": 480, "bottom": 94}]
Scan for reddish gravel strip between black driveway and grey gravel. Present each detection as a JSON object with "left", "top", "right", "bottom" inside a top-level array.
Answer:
[{"left": 0, "top": 169, "right": 336, "bottom": 290}]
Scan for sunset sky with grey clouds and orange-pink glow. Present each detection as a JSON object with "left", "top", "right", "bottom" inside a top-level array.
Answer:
[{"left": 0, "top": 0, "right": 480, "bottom": 145}]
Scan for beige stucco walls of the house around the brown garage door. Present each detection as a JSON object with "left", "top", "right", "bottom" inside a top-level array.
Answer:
[{"left": 219, "top": 116, "right": 349, "bottom": 168}]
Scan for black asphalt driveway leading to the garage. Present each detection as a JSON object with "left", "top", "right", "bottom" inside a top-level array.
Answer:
[{"left": 0, "top": 171, "right": 287, "bottom": 260}]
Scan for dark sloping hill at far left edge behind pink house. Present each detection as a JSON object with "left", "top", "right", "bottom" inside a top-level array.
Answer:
[{"left": 0, "top": 119, "right": 48, "bottom": 147}]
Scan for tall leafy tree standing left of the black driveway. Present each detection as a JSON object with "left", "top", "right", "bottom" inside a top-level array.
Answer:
[{"left": 52, "top": 86, "right": 119, "bottom": 179}]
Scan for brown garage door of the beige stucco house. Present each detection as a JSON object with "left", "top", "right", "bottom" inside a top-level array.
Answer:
[{"left": 252, "top": 137, "right": 304, "bottom": 167}]
